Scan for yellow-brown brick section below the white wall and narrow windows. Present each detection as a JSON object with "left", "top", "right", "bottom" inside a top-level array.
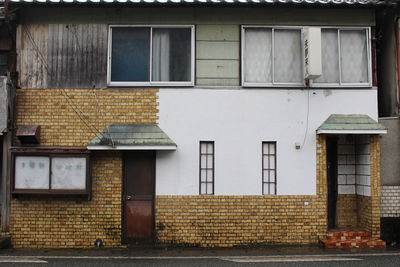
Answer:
[{"left": 156, "top": 196, "right": 326, "bottom": 247}]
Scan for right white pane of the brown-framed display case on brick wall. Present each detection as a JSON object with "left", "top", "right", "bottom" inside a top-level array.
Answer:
[{"left": 51, "top": 157, "right": 86, "bottom": 190}]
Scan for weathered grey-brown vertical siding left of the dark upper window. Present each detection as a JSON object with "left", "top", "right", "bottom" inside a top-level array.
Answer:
[{"left": 17, "top": 24, "right": 107, "bottom": 89}]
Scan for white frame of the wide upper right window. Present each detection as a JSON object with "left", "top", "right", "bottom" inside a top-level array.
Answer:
[{"left": 240, "top": 25, "right": 372, "bottom": 88}]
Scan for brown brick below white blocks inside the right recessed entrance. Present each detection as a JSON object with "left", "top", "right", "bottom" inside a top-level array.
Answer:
[{"left": 336, "top": 194, "right": 357, "bottom": 227}]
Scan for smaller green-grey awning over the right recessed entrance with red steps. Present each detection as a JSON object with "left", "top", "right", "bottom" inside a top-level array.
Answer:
[{"left": 317, "top": 114, "right": 387, "bottom": 134}]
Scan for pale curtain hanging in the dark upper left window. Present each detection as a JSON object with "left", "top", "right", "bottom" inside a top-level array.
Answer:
[{"left": 152, "top": 29, "right": 170, "bottom": 81}]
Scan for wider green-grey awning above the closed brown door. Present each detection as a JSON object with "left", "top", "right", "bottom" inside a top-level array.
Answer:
[{"left": 86, "top": 124, "right": 177, "bottom": 150}]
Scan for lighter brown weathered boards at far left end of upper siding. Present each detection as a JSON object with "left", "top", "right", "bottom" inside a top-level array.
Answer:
[{"left": 17, "top": 24, "right": 48, "bottom": 89}]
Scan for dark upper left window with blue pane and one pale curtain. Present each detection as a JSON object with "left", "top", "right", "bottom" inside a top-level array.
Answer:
[{"left": 107, "top": 26, "right": 194, "bottom": 86}]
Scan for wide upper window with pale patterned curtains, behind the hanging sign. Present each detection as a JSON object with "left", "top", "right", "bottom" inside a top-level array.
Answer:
[{"left": 242, "top": 26, "right": 372, "bottom": 87}]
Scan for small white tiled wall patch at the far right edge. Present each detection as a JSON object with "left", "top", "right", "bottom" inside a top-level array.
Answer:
[{"left": 381, "top": 185, "right": 400, "bottom": 220}]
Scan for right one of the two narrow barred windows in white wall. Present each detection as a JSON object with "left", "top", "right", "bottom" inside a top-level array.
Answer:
[{"left": 262, "top": 142, "right": 276, "bottom": 195}]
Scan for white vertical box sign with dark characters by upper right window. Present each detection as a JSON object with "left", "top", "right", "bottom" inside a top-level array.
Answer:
[{"left": 303, "top": 27, "right": 322, "bottom": 79}]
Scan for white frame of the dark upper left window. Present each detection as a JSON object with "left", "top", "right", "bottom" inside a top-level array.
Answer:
[{"left": 107, "top": 25, "right": 195, "bottom": 86}]
